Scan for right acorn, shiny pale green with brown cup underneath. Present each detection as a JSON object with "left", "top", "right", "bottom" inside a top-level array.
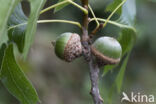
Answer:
[{"left": 91, "top": 36, "right": 122, "bottom": 67}]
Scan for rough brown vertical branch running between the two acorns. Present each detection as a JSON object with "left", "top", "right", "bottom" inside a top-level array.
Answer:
[{"left": 81, "top": 0, "right": 103, "bottom": 104}]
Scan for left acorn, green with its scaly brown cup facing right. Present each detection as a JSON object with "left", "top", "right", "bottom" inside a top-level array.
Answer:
[{"left": 55, "top": 32, "right": 82, "bottom": 62}]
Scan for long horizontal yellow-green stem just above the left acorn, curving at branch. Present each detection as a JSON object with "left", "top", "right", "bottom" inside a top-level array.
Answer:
[{"left": 8, "top": 20, "right": 82, "bottom": 30}]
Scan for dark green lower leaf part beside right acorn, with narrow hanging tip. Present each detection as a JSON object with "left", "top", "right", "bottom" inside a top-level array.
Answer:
[{"left": 116, "top": 28, "right": 136, "bottom": 92}]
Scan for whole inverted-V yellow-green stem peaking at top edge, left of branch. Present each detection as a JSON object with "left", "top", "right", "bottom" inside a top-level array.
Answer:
[{"left": 40, "top": 0, "right": 88, "bottom": 14}]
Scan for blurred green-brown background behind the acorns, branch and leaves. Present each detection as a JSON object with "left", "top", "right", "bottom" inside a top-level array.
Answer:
[{"left": 0, "top": 0, "right": 156, "bottom": 104}]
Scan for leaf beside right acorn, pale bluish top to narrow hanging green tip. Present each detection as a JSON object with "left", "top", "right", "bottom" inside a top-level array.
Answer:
[{"left": 116, "top": 0, "right": 136, "bottom": 92}]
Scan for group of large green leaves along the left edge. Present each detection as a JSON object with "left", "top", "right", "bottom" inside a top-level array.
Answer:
[{"left": 0, "top": 0, "right": 45, "bottom": 104}]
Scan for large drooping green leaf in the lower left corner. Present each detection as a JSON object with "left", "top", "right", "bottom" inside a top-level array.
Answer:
[{"left": 0, "top": 44, "right": 39, "bottom": 104}]
